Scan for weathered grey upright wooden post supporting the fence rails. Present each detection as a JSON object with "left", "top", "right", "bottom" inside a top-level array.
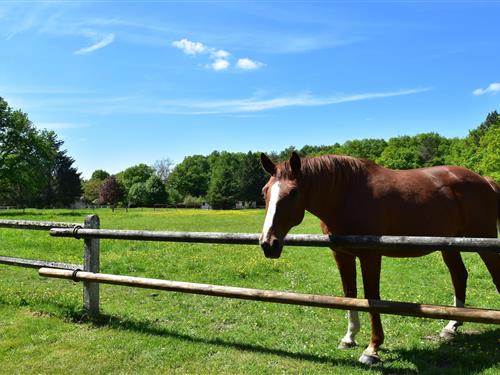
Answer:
[{"left": 83, "top": 215, "right": 100, "bottom": 320}]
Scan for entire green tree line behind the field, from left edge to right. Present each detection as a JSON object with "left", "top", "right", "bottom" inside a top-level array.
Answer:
[{"left": 0, "top": 98, "right": 500, "bottom": 209}]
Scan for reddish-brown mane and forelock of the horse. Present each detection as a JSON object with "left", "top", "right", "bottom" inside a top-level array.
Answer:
[{"left": 276, "top": 155, "right": 374, "bottom": 187}]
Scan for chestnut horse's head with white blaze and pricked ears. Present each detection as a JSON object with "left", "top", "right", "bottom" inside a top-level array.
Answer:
[{"left": 260, "top": 152, "right": 305, "bottom": 258}]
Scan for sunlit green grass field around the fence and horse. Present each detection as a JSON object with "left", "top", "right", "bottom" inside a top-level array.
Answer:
[{"left": 0, "top": 209, "right": 500, "bottom": 374}]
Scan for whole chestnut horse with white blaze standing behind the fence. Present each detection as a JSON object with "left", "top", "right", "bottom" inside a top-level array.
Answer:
[{"left": 260, "top": 153, "right": 500, "bottom": 364}]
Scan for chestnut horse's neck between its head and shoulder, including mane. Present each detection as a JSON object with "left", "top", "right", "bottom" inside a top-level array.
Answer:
[{"left": 300, "top": 157, "right": 366, "bottom": 222}]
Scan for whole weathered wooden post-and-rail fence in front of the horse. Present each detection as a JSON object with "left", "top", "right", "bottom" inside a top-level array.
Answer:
[{"left": 0, "top": 215, "right": 500, "bottom": 324}]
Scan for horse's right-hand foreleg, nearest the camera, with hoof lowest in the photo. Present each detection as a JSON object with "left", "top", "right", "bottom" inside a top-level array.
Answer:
[{"left": 359, "top": 255, "right": 384, "bottom": 365}]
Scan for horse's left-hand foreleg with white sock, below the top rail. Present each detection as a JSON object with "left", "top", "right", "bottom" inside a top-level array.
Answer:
[{"left": 333, "top": 251, "right": 360, "bottom": 349}]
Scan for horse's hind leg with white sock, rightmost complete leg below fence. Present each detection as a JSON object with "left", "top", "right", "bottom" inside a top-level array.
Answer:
[{"left": 439, "top": 251, "right": 467, "bottom": 339}]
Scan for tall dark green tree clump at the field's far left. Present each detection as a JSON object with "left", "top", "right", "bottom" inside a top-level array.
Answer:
[{"left": 0, "top": 97, "right": 82, "bottom": 207}]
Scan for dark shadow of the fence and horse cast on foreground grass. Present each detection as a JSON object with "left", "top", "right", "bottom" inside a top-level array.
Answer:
[{"left": 84, "top": 315, "right": 500, "bottom": 375}]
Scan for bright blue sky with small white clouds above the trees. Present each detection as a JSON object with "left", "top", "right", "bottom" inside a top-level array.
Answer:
[{"left": 0, "top": 0, "right": 500, "bottom": 177}]
